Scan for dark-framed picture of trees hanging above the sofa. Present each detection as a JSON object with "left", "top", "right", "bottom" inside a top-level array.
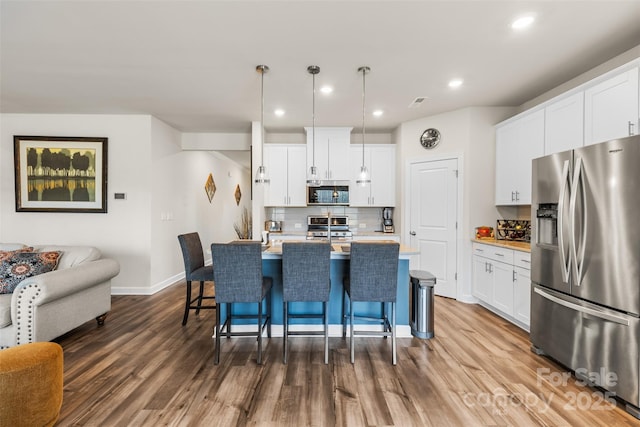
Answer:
[{"left": 13, "top": 135, "right": 108, "bottom": 213}]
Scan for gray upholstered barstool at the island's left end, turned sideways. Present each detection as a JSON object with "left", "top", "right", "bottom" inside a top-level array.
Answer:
[{"left": 178, "top": 233, "right": 216, "bottom": 326}]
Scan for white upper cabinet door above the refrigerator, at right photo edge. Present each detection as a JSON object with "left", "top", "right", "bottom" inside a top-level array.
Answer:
[{"left": 584, "top": 67, "right": 640, "bottom": 145}]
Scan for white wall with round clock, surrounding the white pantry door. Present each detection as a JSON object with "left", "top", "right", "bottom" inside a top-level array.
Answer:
[{"left": 394, "top": 107, "right": 514, "bottom": 301}]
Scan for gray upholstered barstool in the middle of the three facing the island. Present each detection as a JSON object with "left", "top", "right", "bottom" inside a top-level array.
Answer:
[{"left": 282, "top": 242, "right": 331, "bottom": 364}]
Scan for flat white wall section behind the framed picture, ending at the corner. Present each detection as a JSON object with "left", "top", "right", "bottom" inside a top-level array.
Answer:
[{"left": 0, "top": 114, "right": 151, "bottom": 287}]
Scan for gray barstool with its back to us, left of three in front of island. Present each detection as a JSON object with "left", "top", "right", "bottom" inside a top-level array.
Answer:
[{"left": 211, "top": 241, "right": 272, "bottom": 365}]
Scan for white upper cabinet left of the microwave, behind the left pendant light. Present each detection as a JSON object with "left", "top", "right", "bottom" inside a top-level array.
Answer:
[{"left": 264, "top": 144, "right": 307, "bottom": 206}]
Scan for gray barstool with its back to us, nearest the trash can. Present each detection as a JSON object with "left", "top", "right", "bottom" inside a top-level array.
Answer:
[{"left": 342, "top": 242, "right": 400, "bottom": 365}]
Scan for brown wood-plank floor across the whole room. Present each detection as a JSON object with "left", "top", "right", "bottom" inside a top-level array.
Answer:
[{"left": 57, "top": 284, "right": 639, "bottom": 426}]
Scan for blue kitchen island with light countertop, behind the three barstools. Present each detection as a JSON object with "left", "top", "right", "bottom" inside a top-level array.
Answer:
[{"left": 219, "top": 242, "right": 418, "bottom": 337}]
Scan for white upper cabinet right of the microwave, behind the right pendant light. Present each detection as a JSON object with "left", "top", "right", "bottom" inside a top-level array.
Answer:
[{"left": 349, "top": 144, "right": 396, "bottom": 207}]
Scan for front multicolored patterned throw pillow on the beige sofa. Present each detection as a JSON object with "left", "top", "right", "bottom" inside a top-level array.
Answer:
[{"left": 0, "top": 251, "right": 62, "bottom": 294}]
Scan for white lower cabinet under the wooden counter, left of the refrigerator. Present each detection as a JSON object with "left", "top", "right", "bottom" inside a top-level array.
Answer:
[{"left": 473, "top": 243, "right": 531, "bottom": 329}]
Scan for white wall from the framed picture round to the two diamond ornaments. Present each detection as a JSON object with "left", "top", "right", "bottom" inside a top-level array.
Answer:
[{"left": 0, "top": 114, "right": 251, "bottom": 294}]
